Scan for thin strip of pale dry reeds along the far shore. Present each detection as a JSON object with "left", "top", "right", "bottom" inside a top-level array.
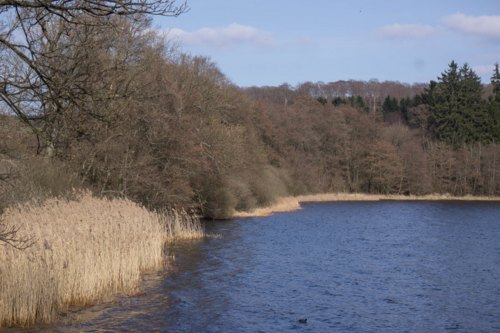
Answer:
[{"left": 231, "top": 193, "right": 500, "bottom": 218}]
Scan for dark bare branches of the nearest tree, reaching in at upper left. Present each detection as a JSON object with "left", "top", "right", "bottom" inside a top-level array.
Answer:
[{"left": 0, "top": 0, "right": 188, "bottom": 155}]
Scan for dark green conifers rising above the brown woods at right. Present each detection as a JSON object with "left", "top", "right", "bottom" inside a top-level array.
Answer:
[{"left": 382, "top": 61, "right": 500, "bottom": 148}]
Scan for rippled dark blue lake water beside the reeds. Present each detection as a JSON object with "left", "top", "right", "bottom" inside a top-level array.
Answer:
[{"left": 13, "top": 201, "right": 500, "bottom": 333}]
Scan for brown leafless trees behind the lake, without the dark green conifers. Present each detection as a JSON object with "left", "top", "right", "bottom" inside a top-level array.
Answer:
[{"left": 0, "top": 11, "right": 500, "bottom": 223}]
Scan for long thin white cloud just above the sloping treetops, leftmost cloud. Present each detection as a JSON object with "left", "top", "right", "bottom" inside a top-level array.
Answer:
[{"left": 167, "top": 23, "right": 276, "bottom": 47}]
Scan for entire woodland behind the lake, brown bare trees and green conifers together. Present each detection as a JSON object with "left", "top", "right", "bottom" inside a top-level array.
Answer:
[{"left": 0, "top": 1, "right": 500, "bottom": 218}]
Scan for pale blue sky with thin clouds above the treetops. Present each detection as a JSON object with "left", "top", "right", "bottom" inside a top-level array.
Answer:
[{"left": 153, "top": 0, "right": 500, "bottom": 87}]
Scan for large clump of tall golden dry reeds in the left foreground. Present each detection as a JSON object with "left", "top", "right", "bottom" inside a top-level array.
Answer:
[{"left": 0, "top": 193, "right": 203, "bottom": 327}]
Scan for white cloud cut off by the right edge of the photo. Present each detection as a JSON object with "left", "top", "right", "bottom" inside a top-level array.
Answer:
[{"left": 443, "top": 13, "right": 500, "bottom": 40}]
